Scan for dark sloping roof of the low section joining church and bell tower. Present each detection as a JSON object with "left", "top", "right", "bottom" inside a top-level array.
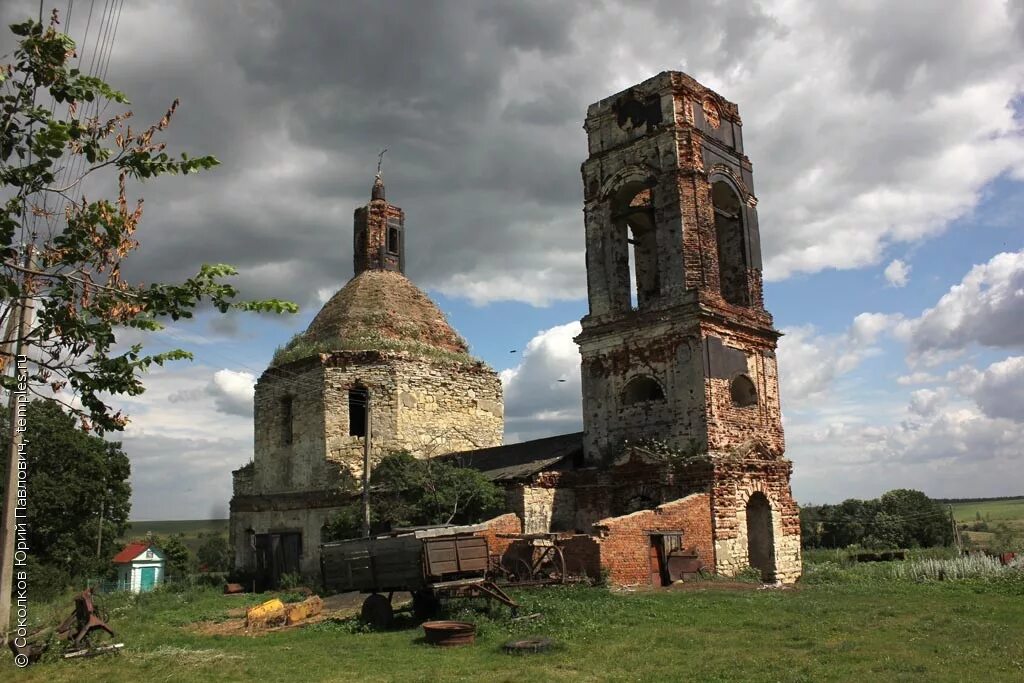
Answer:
[{"left": 442, "top": 432, "right": 583, "bottom": 481}]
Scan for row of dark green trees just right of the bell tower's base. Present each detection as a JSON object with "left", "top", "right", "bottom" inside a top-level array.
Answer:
[{"left": 800, "top": 488, "right": 953, "bottom": 550}]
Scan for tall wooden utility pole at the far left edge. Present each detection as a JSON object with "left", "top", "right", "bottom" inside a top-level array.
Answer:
[{"left": 0, "top": 245, "right": 33, "bottom": 644}]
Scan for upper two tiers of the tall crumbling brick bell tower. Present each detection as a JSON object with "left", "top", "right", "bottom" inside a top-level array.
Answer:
[{"left": 577, "top": 72, "right": 788, "bottom": 466}]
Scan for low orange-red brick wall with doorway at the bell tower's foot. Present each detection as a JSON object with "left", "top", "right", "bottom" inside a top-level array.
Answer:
[{"left": 594, "top": 494, "right": 715, "bottom": 586}]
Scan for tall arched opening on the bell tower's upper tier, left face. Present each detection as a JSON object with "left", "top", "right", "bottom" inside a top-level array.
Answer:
[{"left": 611, "top": 181, "right": 662, "bottom": 308}]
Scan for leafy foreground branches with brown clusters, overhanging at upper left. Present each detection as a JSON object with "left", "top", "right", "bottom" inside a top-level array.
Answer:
[{"left": 0, "top": 13, "right": 297, "bottom": 432}]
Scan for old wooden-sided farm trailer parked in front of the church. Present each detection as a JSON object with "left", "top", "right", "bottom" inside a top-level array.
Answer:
[{"left": 321, "top": 524, "right": 518, "bottom": 628}]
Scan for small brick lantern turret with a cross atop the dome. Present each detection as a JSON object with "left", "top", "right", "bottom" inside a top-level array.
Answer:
[{"left": 352, "top": 163, "right": 406, "bottom": 275}]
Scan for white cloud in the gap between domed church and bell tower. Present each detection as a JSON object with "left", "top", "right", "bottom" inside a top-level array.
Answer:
[{"left": 501, "top": 322, "right": 583, "bottom": 442}]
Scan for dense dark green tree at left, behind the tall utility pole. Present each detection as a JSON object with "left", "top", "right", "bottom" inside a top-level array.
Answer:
[{"left": 0, "top": 399, "right": 131, "bottom": 579}]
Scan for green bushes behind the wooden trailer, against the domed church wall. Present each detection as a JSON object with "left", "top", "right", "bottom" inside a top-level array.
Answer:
[{"left": 325, "top": 453, "right": 504, "bottom": 540}]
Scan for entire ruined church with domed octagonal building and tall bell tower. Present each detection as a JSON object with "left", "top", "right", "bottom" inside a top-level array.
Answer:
[{"left": 230, "top": 72, "right": 801, "bottom": 585}]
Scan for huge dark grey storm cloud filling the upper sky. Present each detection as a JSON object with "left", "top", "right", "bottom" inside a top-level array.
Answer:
[{"left": 0, "top": 0, "right": 1022, "bottom": 305}]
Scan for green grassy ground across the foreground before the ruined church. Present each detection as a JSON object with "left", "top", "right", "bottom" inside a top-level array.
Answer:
[{"left": 8, "top": 572, "right": 1024, "bottom": 683}]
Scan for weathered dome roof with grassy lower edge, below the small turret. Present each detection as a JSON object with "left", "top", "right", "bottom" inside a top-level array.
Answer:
[{"left": 272, "top": 270, "right": 471, "bottom": 365}]
